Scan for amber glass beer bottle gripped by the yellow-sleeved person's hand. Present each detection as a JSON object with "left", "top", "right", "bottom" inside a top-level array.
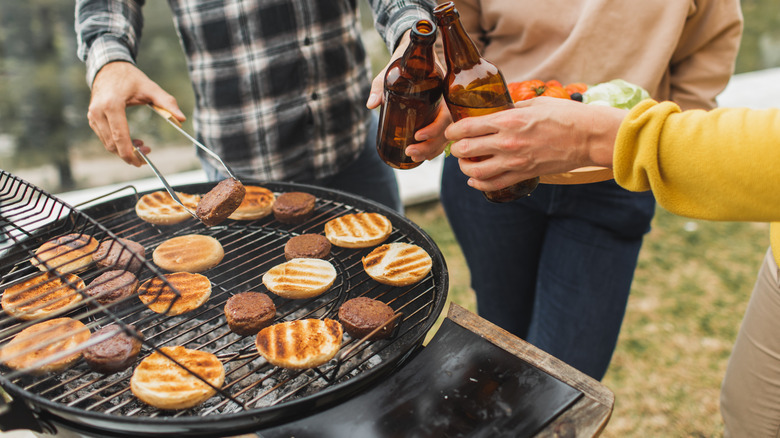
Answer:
[{"left": 433, "top": 2, "right": 539, "bottom": 202}]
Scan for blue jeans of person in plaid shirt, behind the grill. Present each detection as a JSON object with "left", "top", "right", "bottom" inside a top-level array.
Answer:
[{"left": 200, "top": 111, "right": 403, "bottom": 214}]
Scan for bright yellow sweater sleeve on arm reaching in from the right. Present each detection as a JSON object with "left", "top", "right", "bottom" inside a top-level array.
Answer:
[{"left": 613, "top": 101, "right": 780, "bottom": 221}]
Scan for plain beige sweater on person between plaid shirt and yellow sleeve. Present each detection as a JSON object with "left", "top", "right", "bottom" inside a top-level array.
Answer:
[{"left": 455, "top": 0, "right": 742, "bottom": 109}]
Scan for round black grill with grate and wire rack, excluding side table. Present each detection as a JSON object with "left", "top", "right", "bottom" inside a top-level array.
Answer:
[{"left": 0, "top": 172, "right": 448, "bottom": 436}]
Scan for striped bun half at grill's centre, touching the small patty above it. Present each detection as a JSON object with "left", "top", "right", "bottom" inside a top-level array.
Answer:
[{"left": 263, "top": 258, "right": 336, "bottom": 299}]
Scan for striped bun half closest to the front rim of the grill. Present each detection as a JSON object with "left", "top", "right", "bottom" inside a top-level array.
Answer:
[{"left": 130, "top": 346, "right": 225, "bottom": 409}]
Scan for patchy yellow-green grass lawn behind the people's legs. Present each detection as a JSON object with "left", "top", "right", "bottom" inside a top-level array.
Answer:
[{"left": 407, "top": 203, "right": 769, "bottom": 438}]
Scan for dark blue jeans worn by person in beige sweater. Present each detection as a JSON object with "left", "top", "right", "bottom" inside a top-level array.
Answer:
[{"left": 441, "top": 157, "right": 655, "bottom": 380}]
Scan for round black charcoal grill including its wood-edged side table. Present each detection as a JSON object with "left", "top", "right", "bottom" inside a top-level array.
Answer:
[{"left": 0, "top": 171, "right": 614, "bottom": 438}]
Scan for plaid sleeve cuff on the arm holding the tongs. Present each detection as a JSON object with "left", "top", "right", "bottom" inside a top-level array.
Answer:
[{"left": 75, "top": 0, "right": 143, "bottom": 86}]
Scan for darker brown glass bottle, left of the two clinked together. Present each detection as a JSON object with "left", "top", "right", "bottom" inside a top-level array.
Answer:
[{"left": 376, "top": 20, "right": 444, "bottom": 169}]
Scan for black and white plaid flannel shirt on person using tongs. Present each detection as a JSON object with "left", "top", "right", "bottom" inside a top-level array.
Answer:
[{"left": 76, "top": 0, "right": 433, "bottom": 181}]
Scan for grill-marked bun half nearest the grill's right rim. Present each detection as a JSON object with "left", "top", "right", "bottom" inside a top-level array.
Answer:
[{"left": 363, "top": 242, "right": 433, "bottom": 286}]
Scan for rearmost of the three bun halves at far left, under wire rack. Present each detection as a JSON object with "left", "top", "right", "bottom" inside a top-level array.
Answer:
[{"left": 30, "top": 233, "right": 98, "bottom": 273}]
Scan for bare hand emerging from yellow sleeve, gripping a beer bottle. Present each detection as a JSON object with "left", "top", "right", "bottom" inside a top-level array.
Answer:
[{"left": 446, "top": 97, "right": 628, "bottom": 191}]
